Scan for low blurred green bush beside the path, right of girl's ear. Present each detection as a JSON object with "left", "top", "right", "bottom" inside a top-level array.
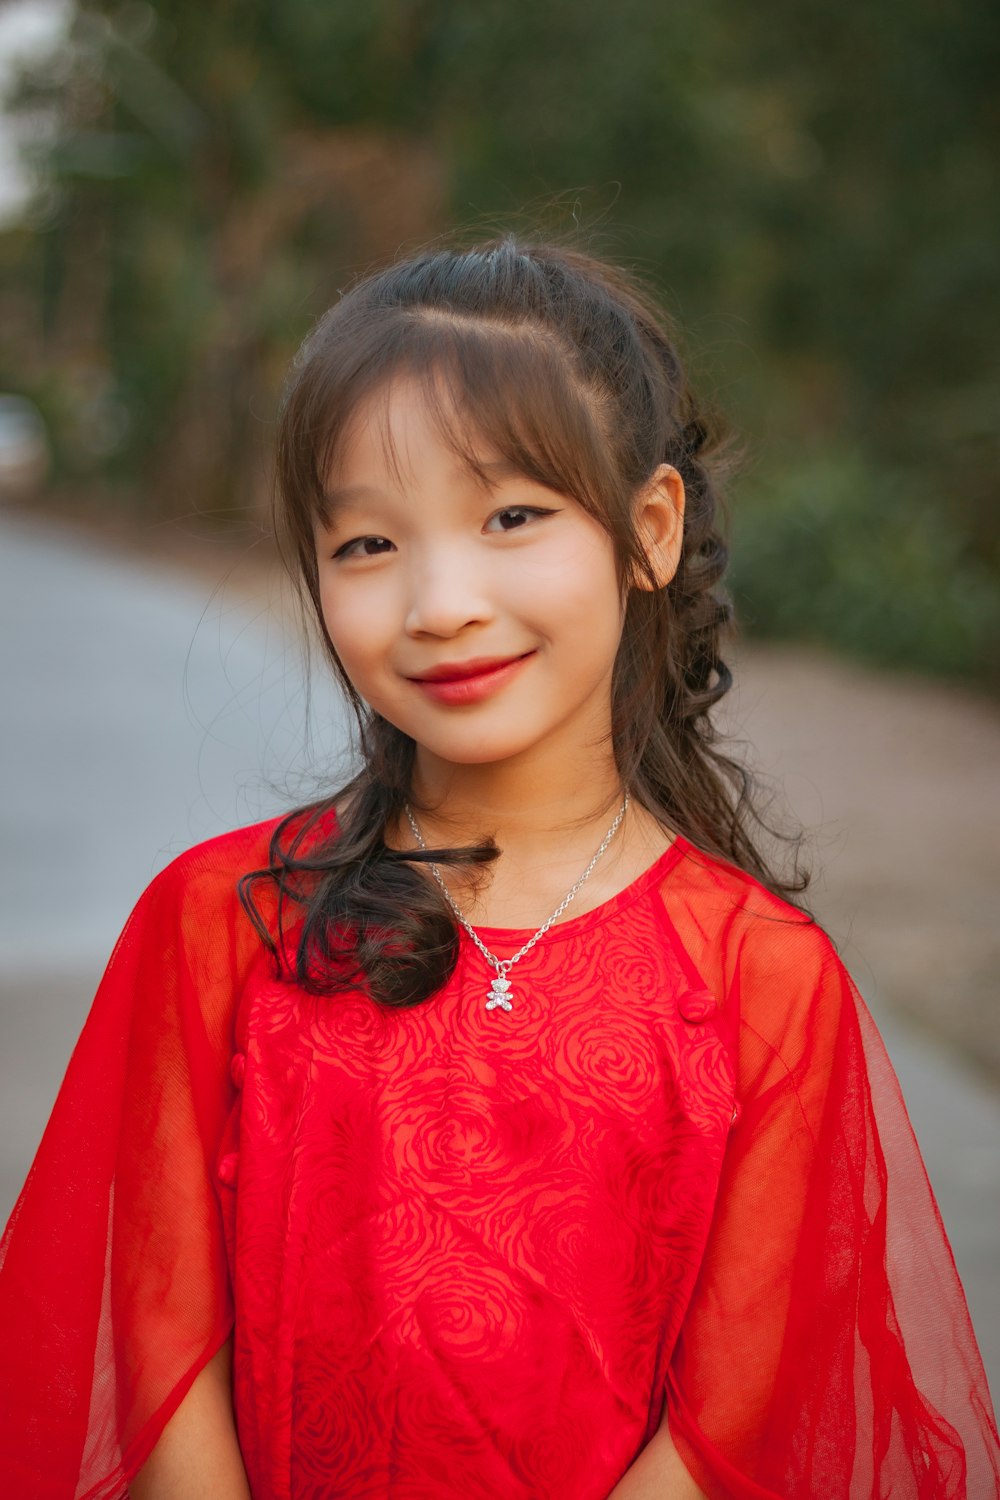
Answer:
[{"left": 732, "top": 449, "right": 1000, "bottom": 687}]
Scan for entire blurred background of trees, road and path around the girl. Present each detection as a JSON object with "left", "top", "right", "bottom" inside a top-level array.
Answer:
[{"left": 0, "top": 0, "right": 1000, "bottom": 1379}]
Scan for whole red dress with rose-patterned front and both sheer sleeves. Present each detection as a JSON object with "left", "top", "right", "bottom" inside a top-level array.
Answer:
[{"left": 0, "top": 825, "right": 1000, "bottom": 1500}]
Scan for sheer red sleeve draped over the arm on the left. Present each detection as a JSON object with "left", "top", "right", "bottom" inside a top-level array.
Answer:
[{"left": 0, "top": 837, "right": 271, "bottom": 1500}]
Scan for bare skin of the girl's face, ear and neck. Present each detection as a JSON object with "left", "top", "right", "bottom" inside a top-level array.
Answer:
[{"left": 316, "top": 380, "right": 684, "bottom": 927}]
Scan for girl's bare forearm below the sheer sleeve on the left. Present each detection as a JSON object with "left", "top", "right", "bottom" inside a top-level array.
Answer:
[{"left": 129, "top": 1340, "right": 250, "bottom": 1500}]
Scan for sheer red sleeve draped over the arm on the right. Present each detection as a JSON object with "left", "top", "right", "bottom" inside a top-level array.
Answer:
[{"left": 667, "top": 891, "right": 1000, "bottom": 1500}]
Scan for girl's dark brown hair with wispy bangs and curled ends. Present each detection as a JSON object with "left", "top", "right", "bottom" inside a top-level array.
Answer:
[{"left": 240, "top": 237, "right": 807, "bottom": 1007}]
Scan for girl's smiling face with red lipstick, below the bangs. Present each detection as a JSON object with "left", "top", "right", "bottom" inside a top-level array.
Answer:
[{"left": 316, "top": 378, "right": 632, "bottom": 765}]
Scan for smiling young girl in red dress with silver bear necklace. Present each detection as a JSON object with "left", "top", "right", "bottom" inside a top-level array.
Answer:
[{"left": 0, "top": 240, "right": 1000, "bottom": 1500}]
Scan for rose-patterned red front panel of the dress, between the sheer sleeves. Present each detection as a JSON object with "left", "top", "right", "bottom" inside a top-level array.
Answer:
[{"left": 223, "top": 854, "right": 733, "bottom": 1500}]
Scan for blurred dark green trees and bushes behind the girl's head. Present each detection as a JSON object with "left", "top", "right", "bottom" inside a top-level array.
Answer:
[{"left": 0, "top": 0, "right": 1000, "bottom": 687}]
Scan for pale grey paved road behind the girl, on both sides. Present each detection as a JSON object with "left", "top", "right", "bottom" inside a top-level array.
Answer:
[{"left": 0, "top": 516, "right": 1000, "bottom": 1389}]
